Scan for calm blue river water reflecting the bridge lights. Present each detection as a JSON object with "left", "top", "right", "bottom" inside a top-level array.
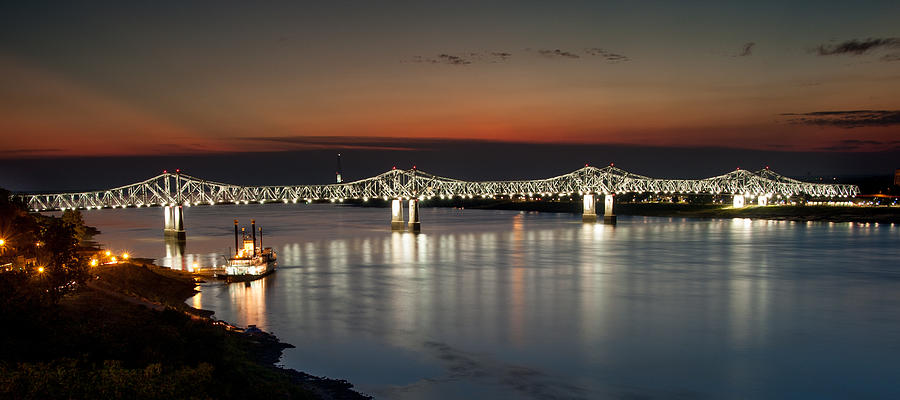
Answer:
[{"left": 84, "top": 205, "right": 900, "bottom": 399}]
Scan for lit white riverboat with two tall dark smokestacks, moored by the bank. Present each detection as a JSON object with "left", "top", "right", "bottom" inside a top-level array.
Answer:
[{"left": 225, "top": 220, "right": 278, "bottom": 282}]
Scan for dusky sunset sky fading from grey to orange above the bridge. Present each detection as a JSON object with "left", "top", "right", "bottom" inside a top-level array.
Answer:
[{"left": 0, "top": 1, "right": 900, "bottom": 187}]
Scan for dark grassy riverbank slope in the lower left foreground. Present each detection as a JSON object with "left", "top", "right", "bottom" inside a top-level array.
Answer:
[{"left": 0, "top": 261, "right": 368, "bottom": 399}]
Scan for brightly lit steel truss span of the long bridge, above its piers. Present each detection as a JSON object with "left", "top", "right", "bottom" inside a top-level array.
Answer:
[{"left": 14, "top": 165, "right": 859, "bottom": 211}]
